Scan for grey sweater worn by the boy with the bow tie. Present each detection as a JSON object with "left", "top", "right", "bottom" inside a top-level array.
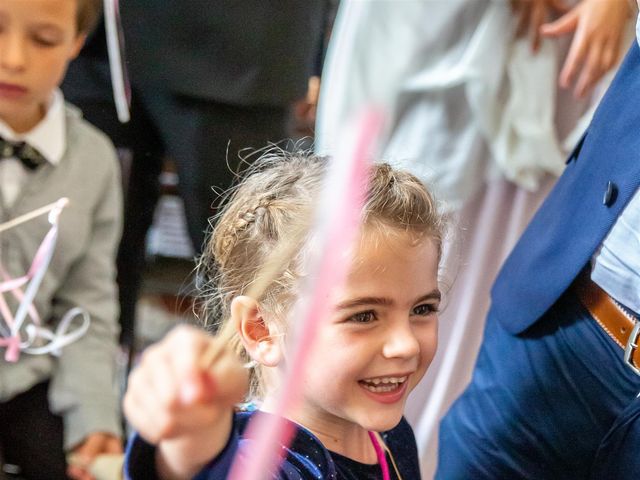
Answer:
[{"left": 0, "top": 106, "right": 122, "bottom": 448}]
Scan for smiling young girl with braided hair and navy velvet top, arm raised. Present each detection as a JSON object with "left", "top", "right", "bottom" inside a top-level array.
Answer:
[{"left": 124, "top": 154, "right": 443, "bottom": 480}]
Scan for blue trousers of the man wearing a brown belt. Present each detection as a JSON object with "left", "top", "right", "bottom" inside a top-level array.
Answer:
[{"left": 436, "top": 291, "right": 640, "bottom": 480}]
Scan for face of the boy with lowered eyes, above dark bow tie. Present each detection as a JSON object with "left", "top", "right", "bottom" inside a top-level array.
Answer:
[{"left": 0, "top": 0, "right": 84, "bottom": 132}]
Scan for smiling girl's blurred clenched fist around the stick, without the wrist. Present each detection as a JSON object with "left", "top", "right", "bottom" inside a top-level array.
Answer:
[{"left": 124, "top": 327, "right": 248, "bottom": 444}]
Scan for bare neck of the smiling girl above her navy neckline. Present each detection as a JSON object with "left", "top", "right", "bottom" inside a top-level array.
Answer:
[{"left": 260, "top": 398, "right": 378, "bottom": 465}]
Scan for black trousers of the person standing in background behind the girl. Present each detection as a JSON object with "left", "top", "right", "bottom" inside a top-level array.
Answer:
[{"left": 69, "top": 90, "right": 288, "bottom": 346}]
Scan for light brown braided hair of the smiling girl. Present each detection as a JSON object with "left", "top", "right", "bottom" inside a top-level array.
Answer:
[{"left": 198, "top": 150, "right": 445, "bottom": 398}]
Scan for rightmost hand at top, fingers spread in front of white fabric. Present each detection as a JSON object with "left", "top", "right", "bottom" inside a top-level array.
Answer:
[{"left": 540, "top": 0, "right": 632, "bottom": 98}]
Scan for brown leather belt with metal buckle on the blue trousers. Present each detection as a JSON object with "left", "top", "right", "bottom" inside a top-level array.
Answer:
[{"left": 573, "top": 268, "right": 640, "bottom": 375}]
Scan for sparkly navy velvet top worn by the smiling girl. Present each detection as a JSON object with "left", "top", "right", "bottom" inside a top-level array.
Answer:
[{"left": 125, "top": 412, "right": 420, "bottom": 480}]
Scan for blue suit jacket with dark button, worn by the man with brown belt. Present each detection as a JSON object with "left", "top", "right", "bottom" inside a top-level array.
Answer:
[{"left": 489, "top": 42, "right": 640, "bottom": 334}]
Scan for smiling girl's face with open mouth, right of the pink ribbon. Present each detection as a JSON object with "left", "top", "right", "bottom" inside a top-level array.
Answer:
[{"left": 293, "top": 231, "right": 440, "bottom": 451}]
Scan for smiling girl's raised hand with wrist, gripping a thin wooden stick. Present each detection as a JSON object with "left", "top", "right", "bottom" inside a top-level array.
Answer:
[{"left": 124, "top": 326, "right": 248, "bottom": 478}]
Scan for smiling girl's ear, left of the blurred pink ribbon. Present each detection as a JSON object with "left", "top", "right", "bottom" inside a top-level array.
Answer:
[{"left": 231, "top": 295, "right": 282, "bottom": 367}]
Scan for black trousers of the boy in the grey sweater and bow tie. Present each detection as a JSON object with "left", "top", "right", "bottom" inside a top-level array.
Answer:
[{"left": 0, "top": 383, "right": 67, "bottom": 480}]
